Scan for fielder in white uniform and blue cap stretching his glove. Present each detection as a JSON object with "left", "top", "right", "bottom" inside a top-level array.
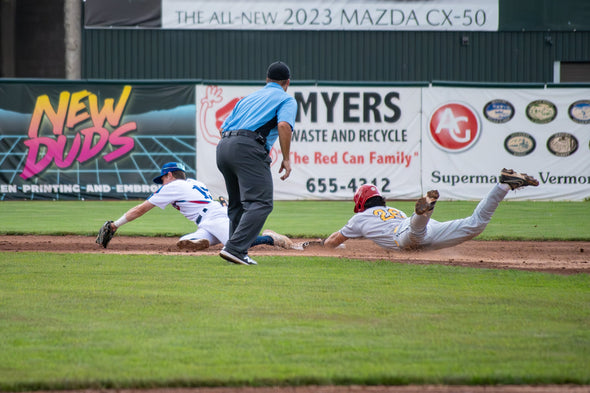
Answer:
[{"left": 106, "top": 162, "right": 293, "bottom": 251}]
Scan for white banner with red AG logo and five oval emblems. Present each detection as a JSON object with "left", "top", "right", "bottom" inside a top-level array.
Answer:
[{"left": 422, "top": 87, "right": 590, "bottom": 200}]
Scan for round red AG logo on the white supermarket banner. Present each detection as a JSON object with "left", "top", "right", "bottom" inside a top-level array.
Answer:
[{"left": 428, "top": 103, "right": 481, "bottom": 153}]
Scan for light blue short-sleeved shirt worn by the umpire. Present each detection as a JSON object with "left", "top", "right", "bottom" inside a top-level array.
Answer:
[{"left": 221, "top": 82, "right": 297, "bottom": 151}]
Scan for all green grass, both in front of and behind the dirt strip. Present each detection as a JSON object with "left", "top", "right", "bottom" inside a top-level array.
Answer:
[{"left": 0, "top": 201, "right": 590, "bottom": 391}]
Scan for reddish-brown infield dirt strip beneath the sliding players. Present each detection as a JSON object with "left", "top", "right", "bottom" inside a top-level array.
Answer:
[{"left": 0, "top": 236, "right": 590, "bottom": 274}]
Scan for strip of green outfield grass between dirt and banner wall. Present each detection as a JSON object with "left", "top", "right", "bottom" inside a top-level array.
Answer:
[{"left": 0, "top": 201, "right": 590, "bottom": 241}]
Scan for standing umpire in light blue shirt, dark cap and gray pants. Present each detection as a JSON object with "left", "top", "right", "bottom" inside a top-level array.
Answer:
[{"left": 217, "top": 61, "right": 297, "bottom": 265}]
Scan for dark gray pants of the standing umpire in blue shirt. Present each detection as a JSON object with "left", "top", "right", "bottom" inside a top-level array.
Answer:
[{"left": 217, "top": 135, "right": 273, "bottom": 258}]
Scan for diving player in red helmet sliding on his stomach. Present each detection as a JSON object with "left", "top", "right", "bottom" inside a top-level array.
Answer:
[{"left": 324, "top": 169, "right": 539, "bottom": 251}]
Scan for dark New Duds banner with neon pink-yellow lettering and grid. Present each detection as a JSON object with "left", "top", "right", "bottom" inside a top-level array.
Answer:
[{"left": 0, "top": 83, "right": 195, "bottom": 200}]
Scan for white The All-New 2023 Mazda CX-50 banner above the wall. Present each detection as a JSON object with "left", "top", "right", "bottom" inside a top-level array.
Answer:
[{"left": 162, "top": 0, "right": 499, "bottom": 31}]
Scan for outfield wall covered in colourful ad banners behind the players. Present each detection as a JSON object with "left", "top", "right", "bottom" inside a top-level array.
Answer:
[{"left": 0, "top": 80, "right": 590, "bottom": 201}]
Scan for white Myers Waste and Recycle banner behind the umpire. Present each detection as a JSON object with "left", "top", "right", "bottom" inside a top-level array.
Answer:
[{"left": 196, "top": 85, "right": 421, "bottom": 200}]
